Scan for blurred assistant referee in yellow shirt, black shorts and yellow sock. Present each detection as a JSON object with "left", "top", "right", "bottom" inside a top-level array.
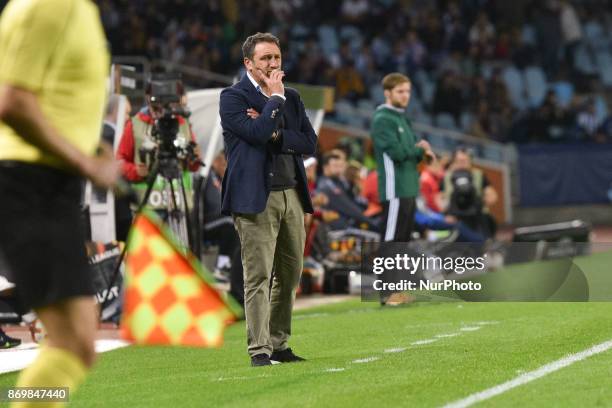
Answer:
[{"left": 0, "top": 0, "right": 120, "bottom": 407}]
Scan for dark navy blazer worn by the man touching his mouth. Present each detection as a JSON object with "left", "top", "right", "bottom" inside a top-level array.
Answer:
[{"left": 219, "top": 75, "right": 317, "bottom": 215}]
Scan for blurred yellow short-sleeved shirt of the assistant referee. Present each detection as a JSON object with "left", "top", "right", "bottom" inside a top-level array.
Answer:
[{"left": 0, "top": 0, "right": 109, "bottom": 167}]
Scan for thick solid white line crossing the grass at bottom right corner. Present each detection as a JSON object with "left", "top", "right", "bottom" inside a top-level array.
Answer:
[{"left": 444, "top": 340, "right": 612, "bottom": 408}]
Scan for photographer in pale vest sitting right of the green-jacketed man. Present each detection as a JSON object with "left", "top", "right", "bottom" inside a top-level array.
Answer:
[{"left": 441, "top": 147, "right": 498, "bottom": 238}]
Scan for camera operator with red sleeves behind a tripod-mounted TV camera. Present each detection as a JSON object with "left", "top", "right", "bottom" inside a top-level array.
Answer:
[{"left": 117, "top": 78, "right": 201, "bottom": 215}]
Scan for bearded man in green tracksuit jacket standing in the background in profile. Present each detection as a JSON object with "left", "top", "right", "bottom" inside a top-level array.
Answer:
[{"left": 371, "top": 73, "right": 435, "bottom": 304}]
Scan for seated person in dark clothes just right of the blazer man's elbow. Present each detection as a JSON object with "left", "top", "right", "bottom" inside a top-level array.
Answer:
[{"left": 317, "top": 153, "right": 377, "bottom": 230}]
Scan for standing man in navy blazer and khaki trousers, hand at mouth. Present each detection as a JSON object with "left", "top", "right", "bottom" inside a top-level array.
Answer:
[{"left": 219, "top": 33, "right": 317, "bottom": 366}]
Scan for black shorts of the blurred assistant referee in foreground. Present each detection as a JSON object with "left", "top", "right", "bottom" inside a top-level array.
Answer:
[{"left": 0, "top": 161, "right": 95, "bottom": 308}]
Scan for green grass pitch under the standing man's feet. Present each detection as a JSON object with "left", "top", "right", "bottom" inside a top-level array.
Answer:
[{"left": 0, "top": 253, "right": 612, "bottom": 408}]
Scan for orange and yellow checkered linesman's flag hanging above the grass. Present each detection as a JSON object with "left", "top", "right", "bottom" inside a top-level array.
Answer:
[{"left": 121, "top": 212, "right": 240, "bottom": 347}]
